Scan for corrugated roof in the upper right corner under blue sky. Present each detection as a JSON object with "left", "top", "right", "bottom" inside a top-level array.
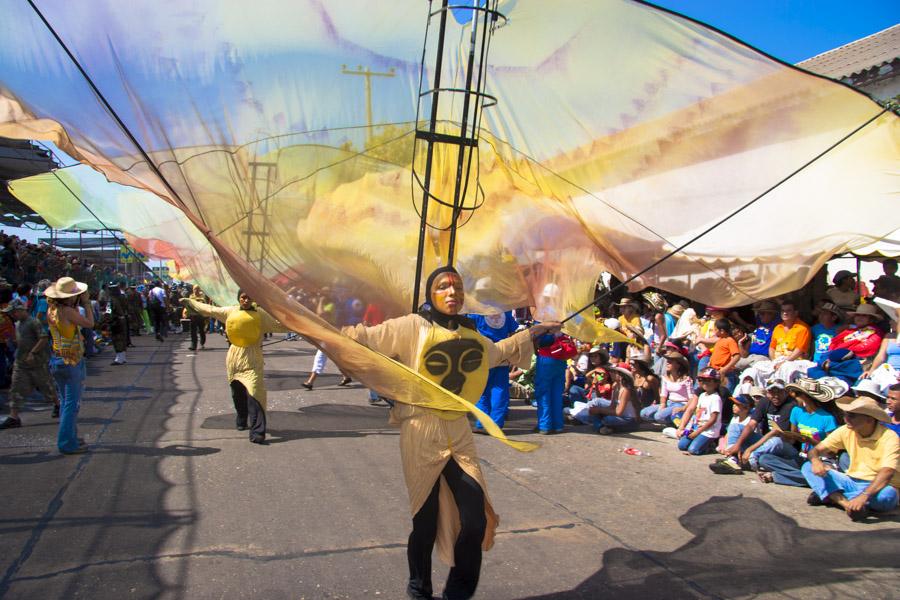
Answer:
[{"left": 797, "top": 24, "right": 900, "bottom": 79}]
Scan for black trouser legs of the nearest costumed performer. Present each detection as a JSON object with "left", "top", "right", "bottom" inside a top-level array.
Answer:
[{"left": 406, "top": 459, "right": 487, "bottom": 600}]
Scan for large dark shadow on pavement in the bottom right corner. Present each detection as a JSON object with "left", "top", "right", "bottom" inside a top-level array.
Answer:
[{"left": 529, "top": 496, "right": 900, "bottom": 600}]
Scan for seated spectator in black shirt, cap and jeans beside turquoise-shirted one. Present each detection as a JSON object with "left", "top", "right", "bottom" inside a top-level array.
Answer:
[{"left": 736, "top": 379, "right": 797, "bottom": 471}]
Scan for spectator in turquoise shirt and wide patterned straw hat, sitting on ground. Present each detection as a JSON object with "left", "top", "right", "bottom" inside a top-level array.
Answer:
[{"left": 759, "top": 378, "right": 838, "bottom": 487}]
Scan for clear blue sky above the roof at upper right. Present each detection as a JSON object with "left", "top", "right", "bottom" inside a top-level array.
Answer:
[{"left": 651, "top": 0, "right": 900, "bottom": 63}]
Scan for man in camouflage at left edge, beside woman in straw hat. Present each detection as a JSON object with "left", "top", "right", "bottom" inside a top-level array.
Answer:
[{"left": 0, "top": 298, "right": 59, "bottom": 429}]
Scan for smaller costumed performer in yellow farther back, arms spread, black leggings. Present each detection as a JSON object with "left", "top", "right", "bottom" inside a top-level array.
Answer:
[{"left": 181, "top": 292, "right": 290, "bottom": 444}]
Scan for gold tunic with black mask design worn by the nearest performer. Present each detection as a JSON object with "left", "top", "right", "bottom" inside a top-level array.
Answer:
[{"left": 343, "top": 314, "right": 534, "bottom": 566}]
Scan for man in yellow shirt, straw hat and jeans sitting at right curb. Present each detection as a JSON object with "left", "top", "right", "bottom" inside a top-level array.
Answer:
[{"left": 801, "top": 396, "right": 900, "bottom": 521}]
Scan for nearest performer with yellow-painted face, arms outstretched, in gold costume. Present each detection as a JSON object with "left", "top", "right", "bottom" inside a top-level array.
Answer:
[{"left": 343, "top": 267, "right": 560, "bottom": 600}]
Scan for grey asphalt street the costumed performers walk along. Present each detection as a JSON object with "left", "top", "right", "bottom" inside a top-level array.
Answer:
[{"left": 0, "top": 335, "right": 900, "bottom": 600}]
